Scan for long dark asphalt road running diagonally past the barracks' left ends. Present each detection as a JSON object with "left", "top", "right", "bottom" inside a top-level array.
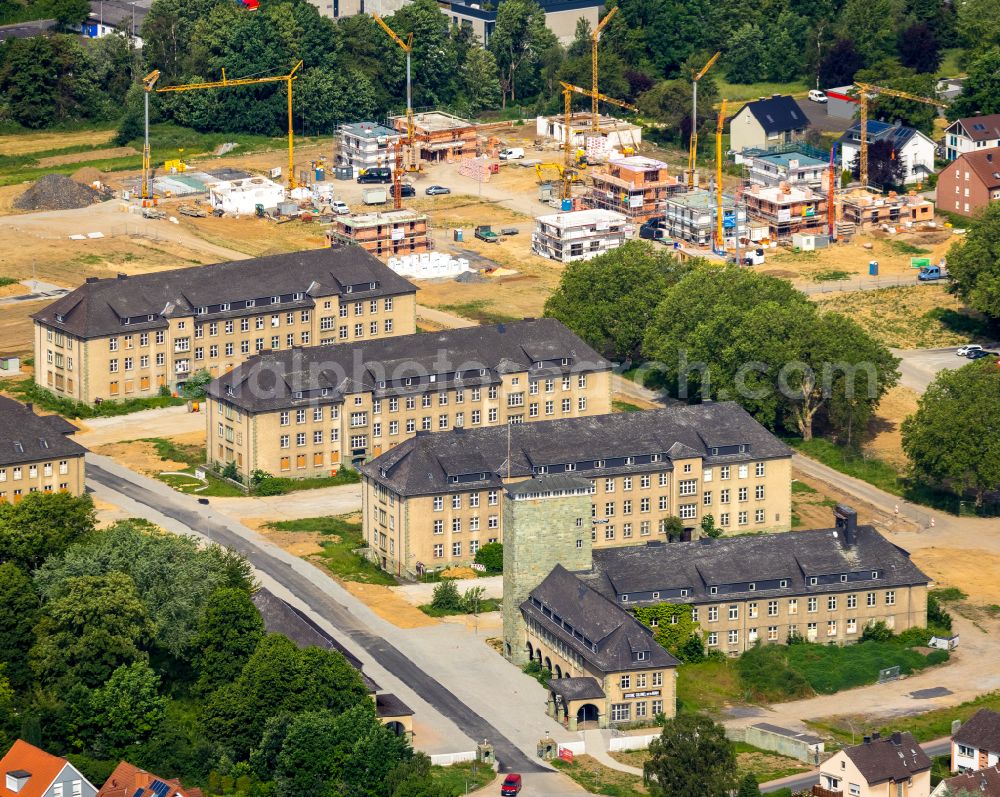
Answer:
[{"left": 87, "top": 462, "right": 551, "bottom": 773}]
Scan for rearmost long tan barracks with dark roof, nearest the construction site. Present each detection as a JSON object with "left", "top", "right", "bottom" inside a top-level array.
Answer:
[{"left": 32, "top": 246, "right": 416, "bottom": 403}]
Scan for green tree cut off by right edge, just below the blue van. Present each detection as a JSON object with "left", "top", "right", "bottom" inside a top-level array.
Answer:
[{"left": 944, "top": 202, "right": 1000, "bottom": 318}]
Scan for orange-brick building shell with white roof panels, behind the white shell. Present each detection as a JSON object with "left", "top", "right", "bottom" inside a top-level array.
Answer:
[{"left": 583, "top": 155, "right": 683, "bottom": 223}]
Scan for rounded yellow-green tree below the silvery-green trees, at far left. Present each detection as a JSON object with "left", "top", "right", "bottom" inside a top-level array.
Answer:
[{"left": 29, "top": 573, "right": 153, "bottom": 688}]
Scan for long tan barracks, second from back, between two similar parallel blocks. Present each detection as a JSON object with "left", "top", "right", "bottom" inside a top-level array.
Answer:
[{"left": 207, "top": 318, "right": 611, "bottom": 488}]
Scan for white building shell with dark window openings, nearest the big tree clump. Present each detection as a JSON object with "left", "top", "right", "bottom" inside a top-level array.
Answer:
[{"left": 531, "top": 210, "right": 633, "bottom": 263}]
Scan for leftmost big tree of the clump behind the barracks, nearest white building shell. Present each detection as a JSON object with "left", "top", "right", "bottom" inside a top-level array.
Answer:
[{"left": 545, "top": 241, "right": 691, "bottom": 360}]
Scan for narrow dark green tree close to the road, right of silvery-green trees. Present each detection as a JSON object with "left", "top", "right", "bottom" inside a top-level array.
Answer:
[{"left": 192, "top": 587, "right": 264, "bottom": 692}]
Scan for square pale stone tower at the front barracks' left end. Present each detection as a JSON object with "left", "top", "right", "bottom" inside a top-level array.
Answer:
[{"left": 503, "top": 474, "right": 592, "bottom": 666}]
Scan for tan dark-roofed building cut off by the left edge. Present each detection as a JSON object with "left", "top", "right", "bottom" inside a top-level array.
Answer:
[{"left": 0, "top": 396, "right": 87, "bottom": 503}]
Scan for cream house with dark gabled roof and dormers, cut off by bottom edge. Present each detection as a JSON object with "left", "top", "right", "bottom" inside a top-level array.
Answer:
[{"left": 813, "top": 732, "right": 931, "bottom": 797}]
